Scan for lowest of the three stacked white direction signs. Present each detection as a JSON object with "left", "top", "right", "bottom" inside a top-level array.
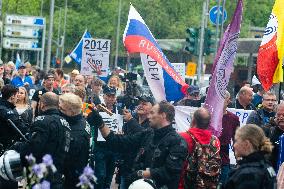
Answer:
[{"left": 3, "top": 37, "right": 41, "bottom": 51}]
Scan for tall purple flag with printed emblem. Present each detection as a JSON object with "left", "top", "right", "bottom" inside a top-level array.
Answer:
[{"left": 204, "top": 0, "right": 243, "bottom": 137}]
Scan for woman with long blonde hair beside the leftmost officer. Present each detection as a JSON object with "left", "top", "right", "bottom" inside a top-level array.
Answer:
[{"left": 16, "top": 87, "right": 33, "bottom": 126}]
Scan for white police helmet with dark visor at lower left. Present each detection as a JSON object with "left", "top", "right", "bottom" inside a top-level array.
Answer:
[{"left": 0, "top": 150, "right": 23, "bottom": 181}]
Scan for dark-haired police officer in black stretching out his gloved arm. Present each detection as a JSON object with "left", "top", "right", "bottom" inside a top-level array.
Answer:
[{"left": 92, "top": 101, "right": 187, "bottom": 189}]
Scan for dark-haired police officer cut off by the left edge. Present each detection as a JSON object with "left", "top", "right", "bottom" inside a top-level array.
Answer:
[{"left": 0, "top": 85, "right": 27, "bottom": 155}]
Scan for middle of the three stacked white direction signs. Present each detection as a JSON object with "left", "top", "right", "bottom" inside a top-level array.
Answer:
[{"left": 4, "top": 25, "right": 41, "bottom": 38}]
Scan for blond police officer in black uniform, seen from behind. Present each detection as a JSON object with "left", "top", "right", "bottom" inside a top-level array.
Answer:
[{"left": 59, "top": 93, "right": 91, "bottom": 189}]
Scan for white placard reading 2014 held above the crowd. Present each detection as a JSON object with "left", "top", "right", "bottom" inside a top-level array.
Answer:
[{"left": 80, "top": 38, "right": 111, "bottom": 77}]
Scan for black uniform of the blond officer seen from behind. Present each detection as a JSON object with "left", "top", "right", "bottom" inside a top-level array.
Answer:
[{"left": 64, "top": 114, "right": 91, "bottom": 189}]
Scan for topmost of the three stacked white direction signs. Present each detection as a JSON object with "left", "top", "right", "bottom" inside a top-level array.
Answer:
[{"left": 5, "top": 15, "right": 45, "bottom": 27}]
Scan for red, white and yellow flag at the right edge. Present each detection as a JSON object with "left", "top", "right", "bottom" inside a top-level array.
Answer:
[{"left": 257, "top": 0, "right": 284, "bottom": 91}]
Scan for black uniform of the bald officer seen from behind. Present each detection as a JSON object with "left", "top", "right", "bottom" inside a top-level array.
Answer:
[{"left": 16, "top": 109, "right": 71, "bottom": 189}]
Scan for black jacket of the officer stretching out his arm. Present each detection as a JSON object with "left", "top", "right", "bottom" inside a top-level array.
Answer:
[{"left": 106, "top": 125, "right": 187, "bottom": 189}]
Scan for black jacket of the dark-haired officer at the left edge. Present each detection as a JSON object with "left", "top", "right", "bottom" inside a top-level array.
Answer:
[{"left": 0, "top": 99, "right": 28, "bottom": 154}]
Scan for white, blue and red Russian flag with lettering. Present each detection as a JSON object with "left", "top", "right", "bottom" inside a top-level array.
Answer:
[{"left": 123, "top": 5, "right": 188, "bottom": 102}]
